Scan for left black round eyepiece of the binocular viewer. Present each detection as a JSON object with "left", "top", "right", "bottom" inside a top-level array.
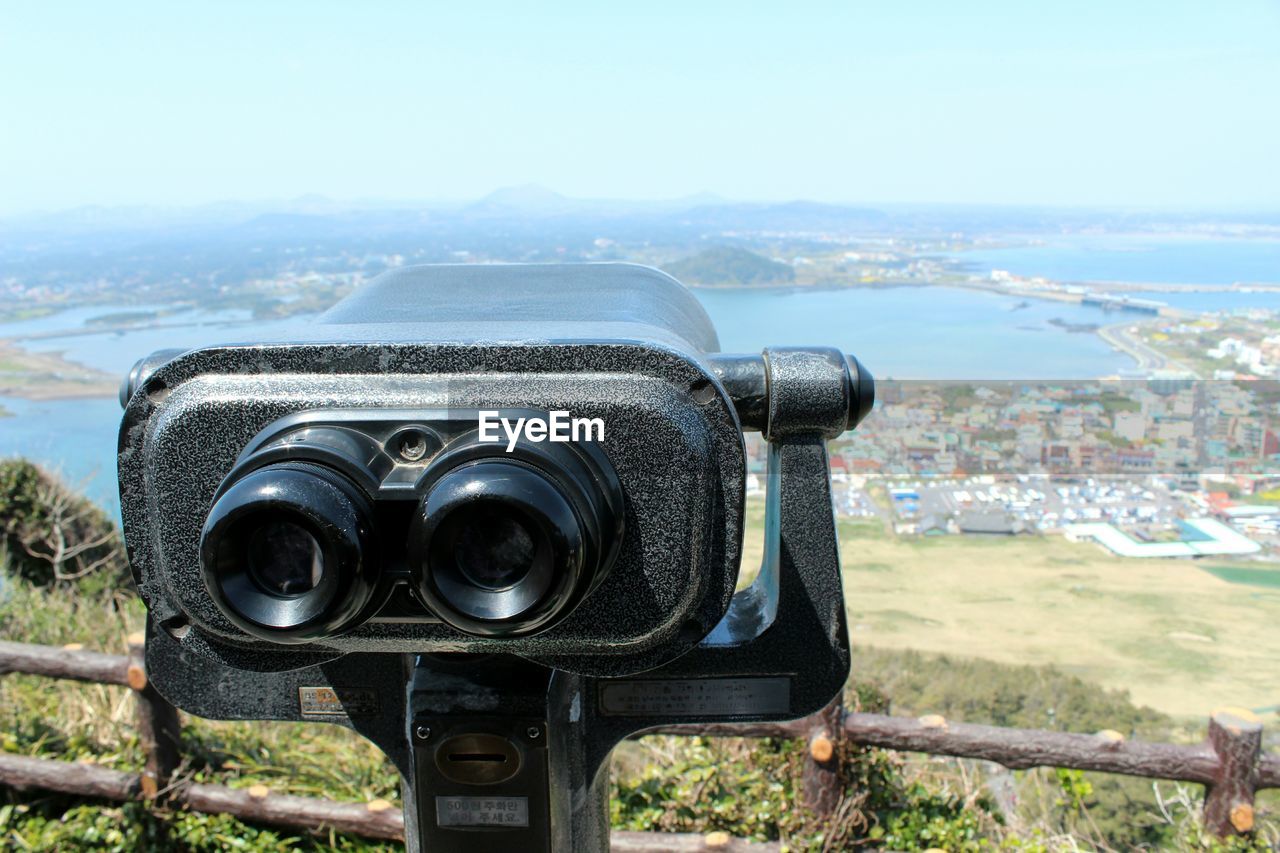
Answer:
[{"left": 200, "top": 462, "right": 378, "bottom": 643}]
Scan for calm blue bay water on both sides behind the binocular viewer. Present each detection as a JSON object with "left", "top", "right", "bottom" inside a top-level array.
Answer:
[{"left": 0, "top": 270, "right": 1280, "bottom": 510}]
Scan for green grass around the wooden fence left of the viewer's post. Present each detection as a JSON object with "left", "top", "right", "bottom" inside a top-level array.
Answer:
[{"left": 0, "top": 576, "right": 401, "bottom": 852}]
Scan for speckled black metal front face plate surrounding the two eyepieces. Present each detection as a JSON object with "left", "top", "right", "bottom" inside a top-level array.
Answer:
[{"left": 122, "top": 356, "right": 744, "bottom": 674}]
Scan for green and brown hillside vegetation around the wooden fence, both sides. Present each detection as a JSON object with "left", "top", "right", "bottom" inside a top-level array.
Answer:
[{"left": 0, "top": 461, "right": 1280, "bottom": 852}]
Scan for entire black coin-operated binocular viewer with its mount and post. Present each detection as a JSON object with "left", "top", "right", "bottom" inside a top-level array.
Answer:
[{"left": 119, "top": 264, "right": 874, "bottom": 850}]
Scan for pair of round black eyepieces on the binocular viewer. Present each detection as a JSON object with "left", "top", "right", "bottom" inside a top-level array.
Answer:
[{"left": 201, "top": 435, "right": 621, "bottom": 643}]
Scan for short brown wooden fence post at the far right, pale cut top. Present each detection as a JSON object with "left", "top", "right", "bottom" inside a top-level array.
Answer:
[{"left": 1204, "top": 708, "right": 1262, "bottom": 836}]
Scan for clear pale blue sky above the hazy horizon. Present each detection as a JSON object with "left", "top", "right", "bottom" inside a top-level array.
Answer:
[{"left": 0, "top": 0, "right": 1280, "bottom": 214}]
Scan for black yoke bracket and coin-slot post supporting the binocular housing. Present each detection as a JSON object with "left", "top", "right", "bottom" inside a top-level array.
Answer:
[{"left": 147, "top": 350, "right": 873, "bottom": 853}]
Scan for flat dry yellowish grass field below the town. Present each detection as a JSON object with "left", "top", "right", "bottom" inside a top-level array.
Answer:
[{"left": 744, "top": 506, "right": 1280, "bottom": 719}]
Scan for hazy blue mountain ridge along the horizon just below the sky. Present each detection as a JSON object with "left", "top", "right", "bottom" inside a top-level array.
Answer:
[{"left": 12, "top": 183, "right": 1280, "bottom": 240}]
